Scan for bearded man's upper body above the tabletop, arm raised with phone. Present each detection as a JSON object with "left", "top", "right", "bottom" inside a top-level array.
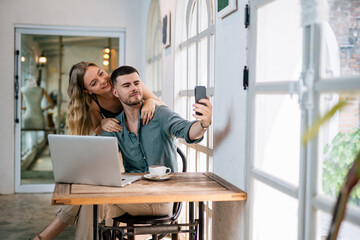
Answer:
[{"left": 101, "top": 66, "right": 212, "bottom": 172}]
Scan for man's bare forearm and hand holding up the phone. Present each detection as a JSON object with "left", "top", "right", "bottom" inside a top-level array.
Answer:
[{"left": 189, "top": 98, "right": 212, "bottom": 140}]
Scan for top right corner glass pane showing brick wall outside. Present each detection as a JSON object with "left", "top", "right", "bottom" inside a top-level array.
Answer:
[{"left": 323, "top": 0, "right": 360, "bottom": 77}]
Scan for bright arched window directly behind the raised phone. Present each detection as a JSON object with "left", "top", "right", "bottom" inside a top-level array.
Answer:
[{"left": 175, "top": 0, "right": 214, "bottom": 171}]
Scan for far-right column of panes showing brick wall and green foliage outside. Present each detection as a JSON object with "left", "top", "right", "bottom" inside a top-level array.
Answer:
[{"left": 307, "top": 0, "right": 360, "bottom": 239}]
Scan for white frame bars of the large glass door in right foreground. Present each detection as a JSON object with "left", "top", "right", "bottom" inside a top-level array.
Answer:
[{"left": 245, "top": 0, "right": 360, "bottom": 240}]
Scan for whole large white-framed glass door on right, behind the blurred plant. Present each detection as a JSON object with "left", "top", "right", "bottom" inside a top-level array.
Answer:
[{"left": 247, "top": 0, "right": 360, "bottom": 240}]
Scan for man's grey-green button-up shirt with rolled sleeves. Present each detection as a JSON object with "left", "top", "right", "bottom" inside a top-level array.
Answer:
[{"left": 101, "top": 106, "right": 203, "bottom": 172}]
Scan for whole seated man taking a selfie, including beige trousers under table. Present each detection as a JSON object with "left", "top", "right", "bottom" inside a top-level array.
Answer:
[{"left": 76, "top": 66, "right": 212, "bottom": 239}]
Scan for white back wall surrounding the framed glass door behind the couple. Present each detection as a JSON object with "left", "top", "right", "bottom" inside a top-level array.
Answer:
[{"left": 0, "top": 0, "right": 150, "bottom": 194}]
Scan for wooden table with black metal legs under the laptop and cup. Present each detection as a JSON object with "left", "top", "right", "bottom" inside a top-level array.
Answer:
[{"left": 52, "top": 172, "right": 247, "bottom": 239}]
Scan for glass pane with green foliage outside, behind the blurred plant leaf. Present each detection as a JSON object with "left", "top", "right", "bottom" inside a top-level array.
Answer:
[{"left": 319, "top": 94, "right": 360, "bottom": 206}]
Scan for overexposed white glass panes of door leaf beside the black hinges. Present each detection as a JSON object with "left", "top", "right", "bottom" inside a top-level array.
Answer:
[{"left": 247, "top": 0, "right": 304, "bottom": 240}]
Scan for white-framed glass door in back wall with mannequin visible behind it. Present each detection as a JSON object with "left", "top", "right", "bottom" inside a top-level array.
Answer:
[{"left": 15, "top": 25, "right": 125, "bottom": 192}]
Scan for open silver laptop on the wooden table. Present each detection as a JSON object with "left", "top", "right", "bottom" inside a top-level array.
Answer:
[{"left": 48, "top": 134, "right": 141, "bottom": 187}]
